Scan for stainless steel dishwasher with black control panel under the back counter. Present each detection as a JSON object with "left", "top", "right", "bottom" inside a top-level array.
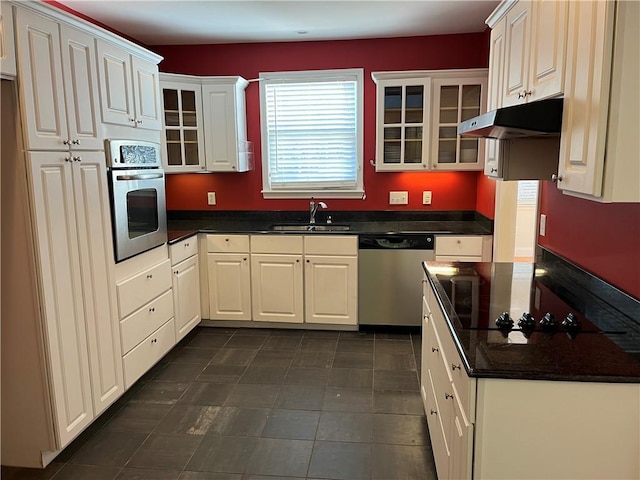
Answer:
[{"left": 358, "top": 233, "right": 435, "bottom": 326}]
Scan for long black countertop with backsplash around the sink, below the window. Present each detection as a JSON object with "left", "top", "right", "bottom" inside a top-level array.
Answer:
[{"left": 167, "top": 211, "right": 493, "bottom": 244}]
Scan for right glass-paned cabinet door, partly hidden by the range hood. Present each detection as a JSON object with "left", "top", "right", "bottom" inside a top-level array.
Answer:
[{"left": 431, "top": 77, "right": 487, "bottom": 170}]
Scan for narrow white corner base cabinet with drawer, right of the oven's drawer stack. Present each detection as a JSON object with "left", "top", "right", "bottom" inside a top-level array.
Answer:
[{"left": 169, "top": 235, "right": 201, "bottom": 342}]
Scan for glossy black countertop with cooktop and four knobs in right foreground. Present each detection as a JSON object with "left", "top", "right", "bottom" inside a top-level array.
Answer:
[{"left": 423, "top": 252, "right": 640, "bottom": 383}]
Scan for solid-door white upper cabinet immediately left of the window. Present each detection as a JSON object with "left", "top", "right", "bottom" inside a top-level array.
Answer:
[{"left": 202, "top": 80, "right": 249, "bottom": 172}]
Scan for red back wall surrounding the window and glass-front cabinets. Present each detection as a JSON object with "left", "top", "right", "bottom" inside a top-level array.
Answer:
[{"left": 151, "top": 32, "right": 494, "bottom": 214}]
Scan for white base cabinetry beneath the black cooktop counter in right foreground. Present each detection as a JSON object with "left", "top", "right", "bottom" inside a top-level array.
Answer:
[{"left": 420, "top": 280, "right": 640, "bottom": 480}]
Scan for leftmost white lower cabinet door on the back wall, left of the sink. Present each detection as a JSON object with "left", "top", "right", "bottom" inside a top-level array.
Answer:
[{"left": 207, "top": 253, "right": 251, "bottom": 320}]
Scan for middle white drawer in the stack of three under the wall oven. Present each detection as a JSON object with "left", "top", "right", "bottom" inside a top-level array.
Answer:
[{"left": 120, "top": 290, "right": 173, "bottom": 353}]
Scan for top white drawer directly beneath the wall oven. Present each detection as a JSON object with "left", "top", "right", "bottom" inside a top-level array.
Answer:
[{"left": 116, "top": 259, "right": 171, "bottom": 319}]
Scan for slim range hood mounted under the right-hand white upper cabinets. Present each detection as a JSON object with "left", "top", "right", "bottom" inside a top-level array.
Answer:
[{"left": 458, "top": 98, "right": 563, "bottom": 140}]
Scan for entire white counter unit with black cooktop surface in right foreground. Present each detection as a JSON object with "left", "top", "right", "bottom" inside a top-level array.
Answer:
[{"left": 421, "top": 252, "right": 640, "bottom": 479}]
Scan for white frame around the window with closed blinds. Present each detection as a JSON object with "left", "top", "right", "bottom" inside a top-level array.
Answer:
[{"left": 259, "top": 68, "right": 364, "bottom": 198}]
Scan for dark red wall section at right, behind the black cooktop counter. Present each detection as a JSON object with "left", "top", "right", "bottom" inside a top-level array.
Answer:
[{"left": 538, "top": 181, "right": 640, "bottom": 299}]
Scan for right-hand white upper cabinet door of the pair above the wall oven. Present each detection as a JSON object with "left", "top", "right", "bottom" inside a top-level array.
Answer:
[{"left": 131, "top": 55, "right": 162, "bottom": 131}]
